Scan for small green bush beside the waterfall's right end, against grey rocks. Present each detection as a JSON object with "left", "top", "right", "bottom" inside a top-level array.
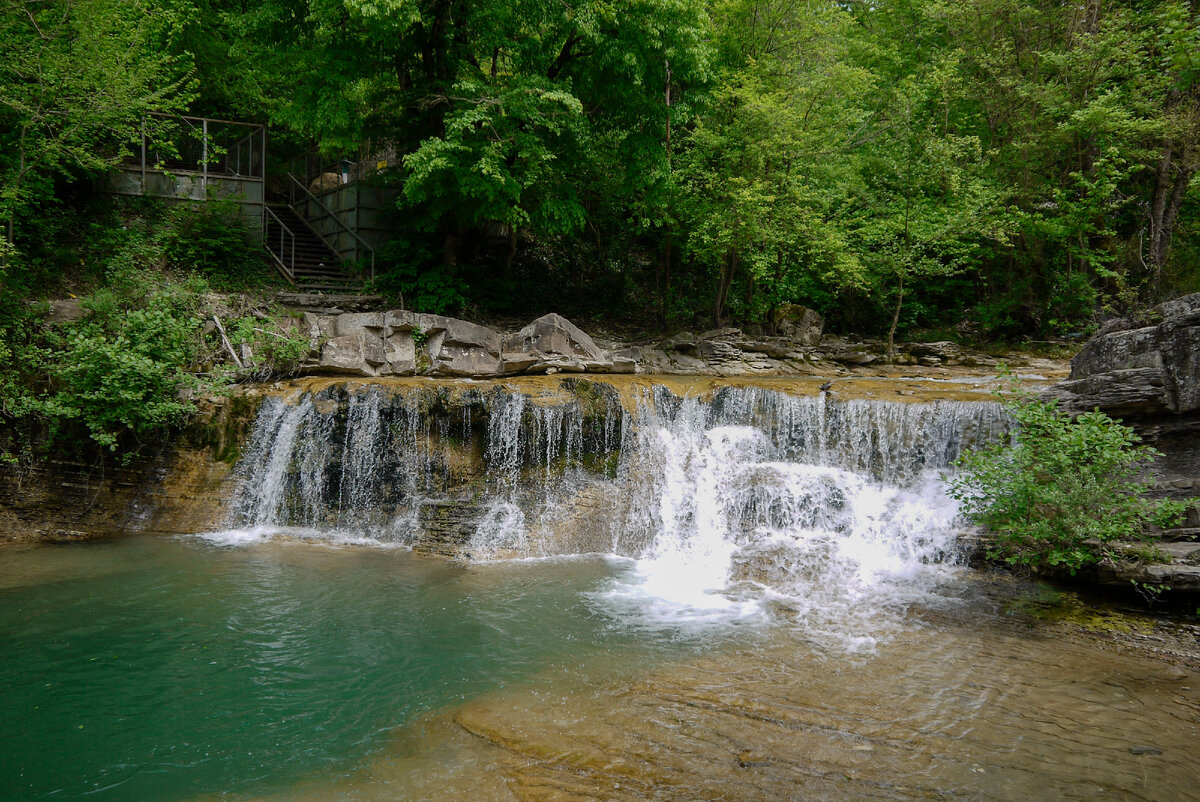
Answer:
[{"left": 950, "top": 374, "right": 1183, "bottom": 574}]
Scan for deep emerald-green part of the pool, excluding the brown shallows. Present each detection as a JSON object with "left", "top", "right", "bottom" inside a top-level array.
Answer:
[{"left": 0, "top": 537, "right": 686, "bottom": 800}]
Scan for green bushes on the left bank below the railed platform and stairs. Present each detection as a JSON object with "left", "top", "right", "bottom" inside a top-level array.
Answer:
[{"left": 0, "top": 203, "right": 308, "bottom": 454}]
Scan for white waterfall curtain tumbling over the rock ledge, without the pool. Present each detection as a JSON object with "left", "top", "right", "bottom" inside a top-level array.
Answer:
[{"left": 220, "top": 381, "right": 1008, "bottom": 646}]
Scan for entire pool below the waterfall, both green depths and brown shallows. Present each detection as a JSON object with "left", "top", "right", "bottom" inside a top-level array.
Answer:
[{"left": 0, "top": 537, "right": 1200, "bottom": 800}]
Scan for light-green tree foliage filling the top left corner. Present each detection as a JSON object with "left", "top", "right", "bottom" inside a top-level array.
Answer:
[{"left": 0, "top": 0, "right": 188, "bottom": 243}]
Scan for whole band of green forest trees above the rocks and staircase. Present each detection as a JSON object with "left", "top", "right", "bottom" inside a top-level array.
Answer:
[{"left": 0, "top": 0, "right": 1200, "bottom": 337}]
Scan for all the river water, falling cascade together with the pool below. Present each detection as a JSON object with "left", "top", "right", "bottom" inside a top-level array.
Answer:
[{"left": 0, "top": 389, "right": 1200, "bottom": 800}]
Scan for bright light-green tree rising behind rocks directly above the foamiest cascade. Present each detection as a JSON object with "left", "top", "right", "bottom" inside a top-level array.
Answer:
[{"left": 679, "top": 0, "right": 875, "bottom": 325}]
